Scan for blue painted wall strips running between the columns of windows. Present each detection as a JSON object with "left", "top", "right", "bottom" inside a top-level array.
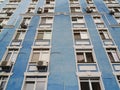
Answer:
[{"left": 0, "top": 0, "right": 120, "bottom": 90}]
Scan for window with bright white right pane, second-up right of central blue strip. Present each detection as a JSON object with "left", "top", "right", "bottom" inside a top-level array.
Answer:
[{"left": 74, "top": 29, "right": 90, "bottom": 45}]
